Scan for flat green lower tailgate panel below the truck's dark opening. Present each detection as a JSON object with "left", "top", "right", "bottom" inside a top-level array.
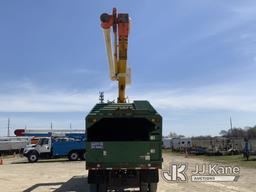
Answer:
[{"left": 86, "top": 141, "right": 161, "bottom": 163}]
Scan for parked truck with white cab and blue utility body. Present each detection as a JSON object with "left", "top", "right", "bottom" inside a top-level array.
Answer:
[{"left": 23, "top": 134, "right": 85, "bottom": 163}]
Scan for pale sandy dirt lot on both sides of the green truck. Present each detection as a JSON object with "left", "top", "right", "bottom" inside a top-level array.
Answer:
[{"left": 0, "top": 153, "right": 256, "bottom": 192}]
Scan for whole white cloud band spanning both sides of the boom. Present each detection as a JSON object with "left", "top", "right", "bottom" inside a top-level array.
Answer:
[{"left": 0, "top": 81, "right": 256, "bottom": 112}]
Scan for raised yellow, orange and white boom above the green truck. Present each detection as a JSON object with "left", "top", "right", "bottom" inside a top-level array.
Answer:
[{"left": 100, "top": 8, "right": 131, "bottom": 103}]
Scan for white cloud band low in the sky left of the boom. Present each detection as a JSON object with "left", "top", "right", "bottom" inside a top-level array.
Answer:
[{"left": 0, "top": 92, "right": 97, "bottom": 112}]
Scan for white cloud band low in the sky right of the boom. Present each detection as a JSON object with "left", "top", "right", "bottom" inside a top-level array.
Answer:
[{"left": 133, "top": 87, "right": 256, "bottom": 112}]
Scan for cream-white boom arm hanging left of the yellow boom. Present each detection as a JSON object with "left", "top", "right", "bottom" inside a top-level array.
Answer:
[{"left": 103, "top": 28, "right": 116, "bottom": 80}]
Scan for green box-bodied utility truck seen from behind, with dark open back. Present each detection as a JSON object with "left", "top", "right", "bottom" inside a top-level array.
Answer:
[{"left": 86, "top": 101, "right": 162, "bottom": 191}]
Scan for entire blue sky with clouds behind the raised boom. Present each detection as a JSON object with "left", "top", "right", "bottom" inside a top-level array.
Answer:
[{"left": 0, "top": 0, "right": 256, "bottom": 136}]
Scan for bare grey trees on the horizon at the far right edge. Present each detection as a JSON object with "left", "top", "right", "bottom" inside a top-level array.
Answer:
[{"left": 220, "top": 125, "right": 256, "bottom": 139}]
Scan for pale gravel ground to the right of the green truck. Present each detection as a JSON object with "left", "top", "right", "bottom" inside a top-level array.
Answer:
[{"left": 158, "top": 153, "right": 256, "bottom": 192}]
